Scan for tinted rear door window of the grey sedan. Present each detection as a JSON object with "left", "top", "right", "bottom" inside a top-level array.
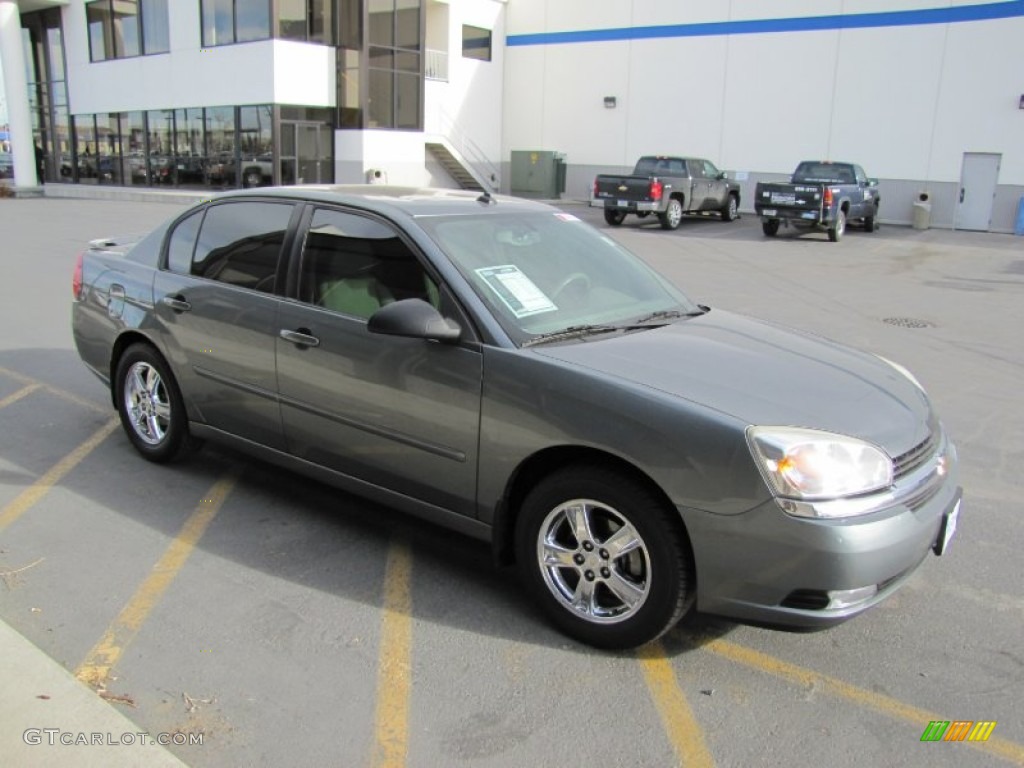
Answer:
[{"left": 190, "top": 202, "right": 294, "bottom": 293}]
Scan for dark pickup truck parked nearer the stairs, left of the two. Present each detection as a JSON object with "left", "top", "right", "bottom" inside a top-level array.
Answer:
[{"left": 591, "top": 155, "right": 739, "bottom": 229}]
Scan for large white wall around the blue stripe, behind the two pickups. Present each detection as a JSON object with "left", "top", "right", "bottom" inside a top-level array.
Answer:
[{"left": 503, "top": 0, "right": 1024, "bottom": 226}]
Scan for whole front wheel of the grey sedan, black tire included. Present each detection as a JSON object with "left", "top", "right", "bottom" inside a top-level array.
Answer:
[{"left": 516, "top": 466, "right": 693, "bottom": 649}]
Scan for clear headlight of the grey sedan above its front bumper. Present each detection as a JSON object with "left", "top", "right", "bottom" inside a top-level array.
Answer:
[{"left": 746, "top": 427, "right": 893, "bottom": 517}]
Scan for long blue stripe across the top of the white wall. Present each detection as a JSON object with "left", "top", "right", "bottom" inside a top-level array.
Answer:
[{"left": 505, "top": 0, "right": 1024, "bottom": 47}]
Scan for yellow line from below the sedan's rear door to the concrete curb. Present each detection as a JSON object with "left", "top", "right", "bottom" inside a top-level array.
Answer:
[{"left": 75, "top": 471, "right": 238, "bottom": 688}]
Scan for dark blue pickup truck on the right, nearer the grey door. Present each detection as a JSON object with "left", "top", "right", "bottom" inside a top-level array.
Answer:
[{"left": 754, "top": 160, "right": 882, "bottom": 243}]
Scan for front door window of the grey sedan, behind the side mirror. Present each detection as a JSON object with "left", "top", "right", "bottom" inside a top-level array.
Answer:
[{"left": 299, "top": 209, "right": 439, "bottom": 319}]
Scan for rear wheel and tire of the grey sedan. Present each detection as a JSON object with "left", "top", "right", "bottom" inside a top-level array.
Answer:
[{"left": 115, "top": 344, "right": 199, "bottom": 464}]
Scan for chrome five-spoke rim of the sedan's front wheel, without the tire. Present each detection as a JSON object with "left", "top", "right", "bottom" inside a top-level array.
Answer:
[{"left": 537, "top": 499, "right": 651, "bottom": 624}]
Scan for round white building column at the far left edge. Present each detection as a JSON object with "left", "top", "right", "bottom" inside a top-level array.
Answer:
[{"left": 0, "top": 0, "right": 39, "bottom": 188}]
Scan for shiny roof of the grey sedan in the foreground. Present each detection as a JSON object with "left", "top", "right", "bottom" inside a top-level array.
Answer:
[{"left": 203, "top": 184, "right": 552, "bottom": 216}]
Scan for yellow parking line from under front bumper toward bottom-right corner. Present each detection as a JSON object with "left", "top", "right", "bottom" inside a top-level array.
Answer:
[{"left": 700, "top": 640, "right": 1024, "bottom": 765}]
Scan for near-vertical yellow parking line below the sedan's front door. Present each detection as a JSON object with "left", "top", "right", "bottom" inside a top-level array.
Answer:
[{"left": 373, "top": 542, "right": 413, "bottom": 768}]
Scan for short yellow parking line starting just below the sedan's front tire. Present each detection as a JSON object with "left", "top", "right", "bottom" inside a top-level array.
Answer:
[{"left": 637, "top": 643, "right": 715, "bottom": 768}]
